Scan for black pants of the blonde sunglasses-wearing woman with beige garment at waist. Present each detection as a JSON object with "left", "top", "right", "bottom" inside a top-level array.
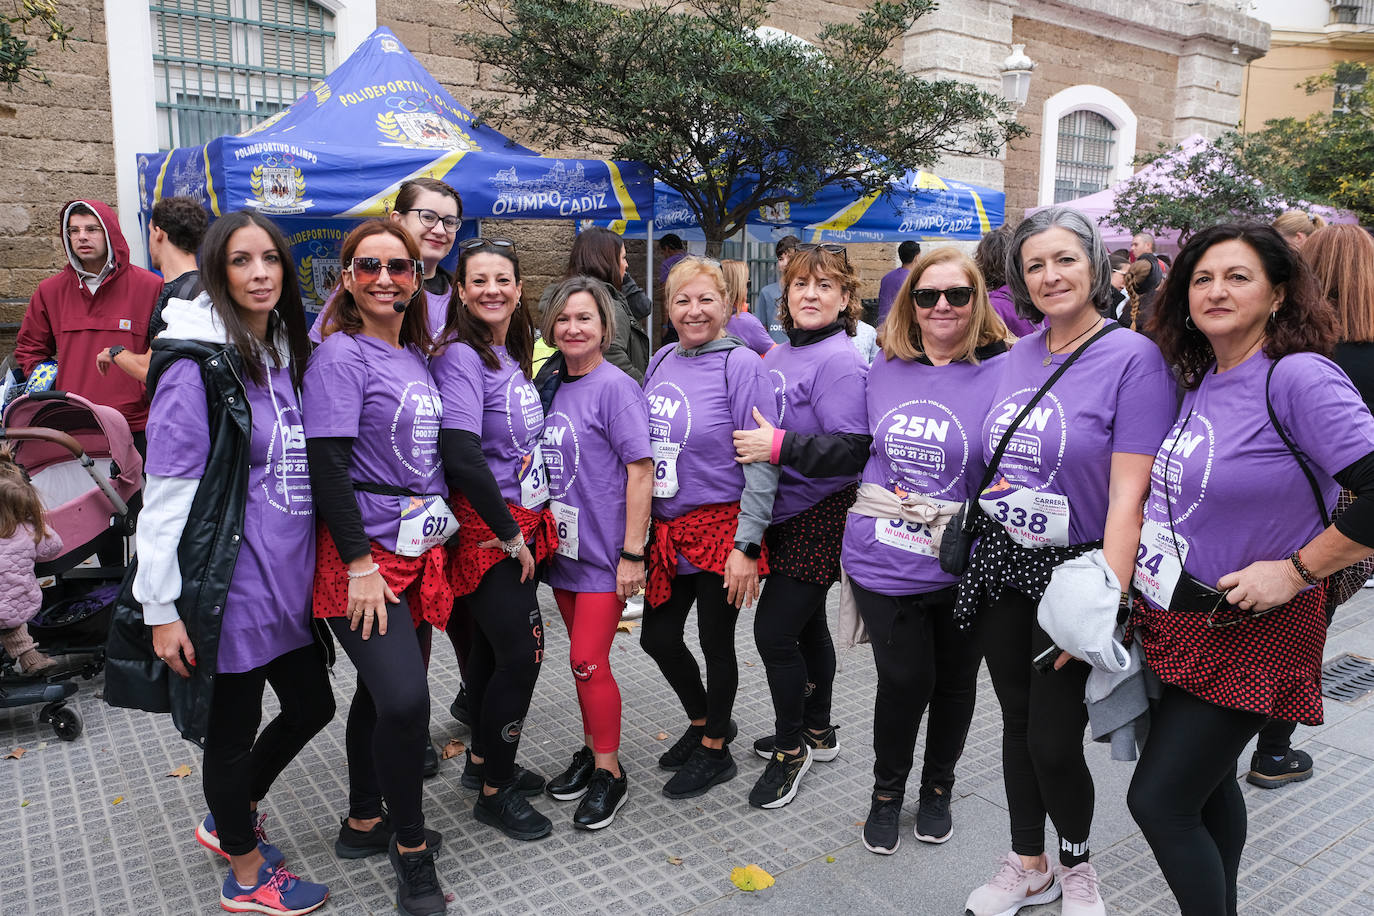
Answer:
[{"left": 849, "top": 581, "right": 982, "bottom": 798}]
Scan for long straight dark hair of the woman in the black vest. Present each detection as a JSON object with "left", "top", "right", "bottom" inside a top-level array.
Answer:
[{"left": 201, "top": 210, "right": 311, "bottom": 387}]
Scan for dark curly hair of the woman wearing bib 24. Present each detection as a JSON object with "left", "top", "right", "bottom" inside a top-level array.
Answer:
[{"left": 1150, "top": 222, "right": 1337, "bottom": 389}]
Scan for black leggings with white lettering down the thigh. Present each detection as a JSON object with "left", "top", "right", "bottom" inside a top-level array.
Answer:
[{"left": 463, "top": 559, "right": 544, "bottom": 788}]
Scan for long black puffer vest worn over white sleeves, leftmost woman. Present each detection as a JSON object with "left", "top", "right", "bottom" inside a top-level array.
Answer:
[{"left": 104, "top": 338, "right": 253, "bottom": 747}]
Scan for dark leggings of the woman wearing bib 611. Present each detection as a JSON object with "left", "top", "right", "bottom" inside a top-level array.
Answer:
[{"left": 328, "top": 596, "right": 429, "bottom": 849}]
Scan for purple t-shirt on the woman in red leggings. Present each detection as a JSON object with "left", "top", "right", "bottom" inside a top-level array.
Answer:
[{"left": 543, "top": 363, "right": 651, "bottom": 592}]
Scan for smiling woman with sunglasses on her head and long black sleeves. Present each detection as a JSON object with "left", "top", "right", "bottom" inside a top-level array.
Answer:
[{"left": 430, "top": 239, "right": 558, "bottom": 840}]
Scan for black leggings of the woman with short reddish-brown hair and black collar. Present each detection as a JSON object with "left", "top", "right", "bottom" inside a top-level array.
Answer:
[{"left": 754, "top": 573, "right": 835, "bottom": 750}]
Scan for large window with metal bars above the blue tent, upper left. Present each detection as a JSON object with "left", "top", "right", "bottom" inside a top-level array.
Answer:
[{"left": 148, "top": 0, "right": 334, "bottom": 148}]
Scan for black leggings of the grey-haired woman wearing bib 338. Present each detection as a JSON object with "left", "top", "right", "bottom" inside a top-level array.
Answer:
[{"left": 978, "top": 589, "right": 1094, "bottom": 867}]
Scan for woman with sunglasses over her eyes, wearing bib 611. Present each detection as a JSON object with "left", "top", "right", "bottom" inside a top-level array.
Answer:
[{"left": 305, "top": 220, "right": 445, "bottom": 916}]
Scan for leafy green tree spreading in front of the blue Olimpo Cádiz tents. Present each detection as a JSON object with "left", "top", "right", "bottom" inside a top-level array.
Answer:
[{"left": 459, "top": 0, "right": 1025, "bottom": 251}]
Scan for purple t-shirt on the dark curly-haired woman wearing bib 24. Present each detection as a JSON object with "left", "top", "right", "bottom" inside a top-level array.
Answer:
[{"left": 1132, "top": 353, "right": 1374, "bottom": 606}]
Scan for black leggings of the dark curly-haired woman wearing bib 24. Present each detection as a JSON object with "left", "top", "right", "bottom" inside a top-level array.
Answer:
[{"left": 1127, "top": 685, "right": 1264, "bottom": 916}]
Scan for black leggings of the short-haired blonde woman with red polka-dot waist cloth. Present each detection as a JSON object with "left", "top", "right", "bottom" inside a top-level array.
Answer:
[{"left": 639, "top": 573, "right": 739, "bottom": 737}]
